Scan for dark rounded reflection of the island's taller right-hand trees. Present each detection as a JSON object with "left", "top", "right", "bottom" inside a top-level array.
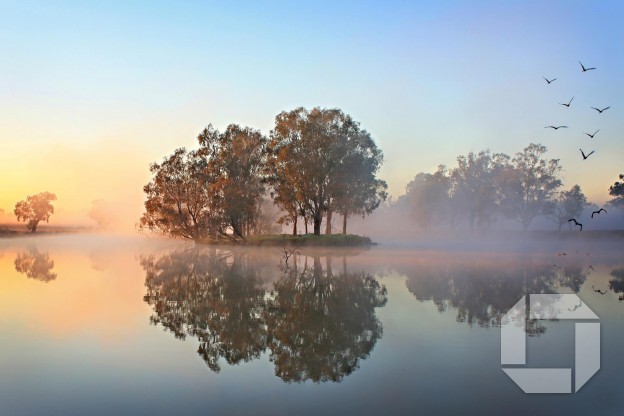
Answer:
[{"left": 267, "top": 257, "right": 387, "bottom": 382}]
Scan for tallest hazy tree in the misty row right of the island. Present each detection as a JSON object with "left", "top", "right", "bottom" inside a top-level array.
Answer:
[{"left": 497, "top": 143, "right": 561, "bottom": 231}]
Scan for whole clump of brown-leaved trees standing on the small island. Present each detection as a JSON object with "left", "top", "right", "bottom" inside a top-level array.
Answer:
[{"left": 140, "top": 107, "right": 387, "bottom": 240}]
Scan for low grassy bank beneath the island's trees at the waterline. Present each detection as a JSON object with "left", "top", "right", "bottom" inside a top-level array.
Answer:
[{"left": 196, "top": 234, "right": 375, "bottom": 247}]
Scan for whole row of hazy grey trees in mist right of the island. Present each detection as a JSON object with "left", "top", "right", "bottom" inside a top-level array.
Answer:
[{"left": 397, "top": 143, "right": 588, "bottom": 230}]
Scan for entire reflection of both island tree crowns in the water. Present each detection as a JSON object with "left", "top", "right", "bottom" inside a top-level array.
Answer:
[{"left": 141, "top": 249, "right": 386, "bottom": 382}]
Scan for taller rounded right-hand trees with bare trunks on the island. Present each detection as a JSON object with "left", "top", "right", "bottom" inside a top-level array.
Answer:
[{"left": 267, "top": 107, "right": 385, "bottom": 235}]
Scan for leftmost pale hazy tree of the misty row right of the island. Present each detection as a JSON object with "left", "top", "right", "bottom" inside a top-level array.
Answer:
[{"left": 405, "top": 165, "right": 450, "bottom": 228}]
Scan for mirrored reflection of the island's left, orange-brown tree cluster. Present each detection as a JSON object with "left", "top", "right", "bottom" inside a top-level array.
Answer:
[{"left": 141, "top": 250, "right": 267, "bottom": 373}]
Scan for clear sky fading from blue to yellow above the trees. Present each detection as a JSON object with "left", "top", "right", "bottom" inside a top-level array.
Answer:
[{"left": 0, "top": 0, "right": 624, "bottom": 229}]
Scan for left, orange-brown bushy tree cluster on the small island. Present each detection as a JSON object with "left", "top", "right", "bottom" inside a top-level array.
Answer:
[{"left": 140, "top": 124, "right": 265, "bottom": 241}]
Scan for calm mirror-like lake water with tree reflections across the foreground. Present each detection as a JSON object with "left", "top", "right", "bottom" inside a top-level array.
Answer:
[{"left": 0, "top": 236, "right": 624, "bottom": 415}]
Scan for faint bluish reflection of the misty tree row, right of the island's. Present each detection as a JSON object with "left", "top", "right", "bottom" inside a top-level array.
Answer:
[{"left": 404, "top": 260, "right": 587, "bottom": 335}]
